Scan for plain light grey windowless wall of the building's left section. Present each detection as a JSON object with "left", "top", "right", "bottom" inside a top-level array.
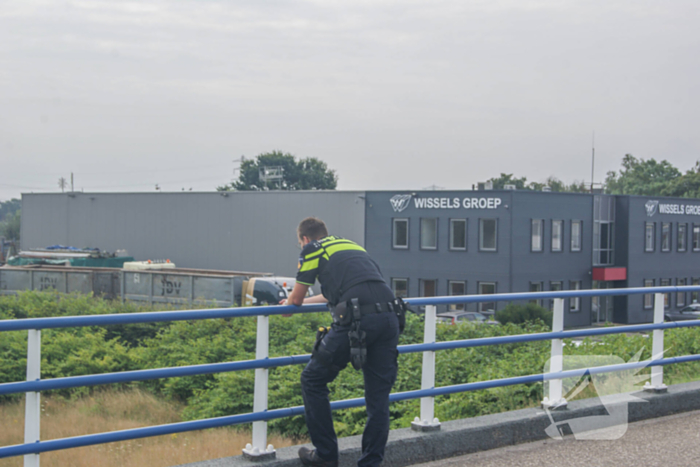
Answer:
[{"left": 21, "top": 191, "right": 365, "bottom": 276}]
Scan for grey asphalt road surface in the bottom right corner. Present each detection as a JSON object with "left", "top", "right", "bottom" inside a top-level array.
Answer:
[{"left": 412, "top": 411, "right": 700, "bottom": 467}]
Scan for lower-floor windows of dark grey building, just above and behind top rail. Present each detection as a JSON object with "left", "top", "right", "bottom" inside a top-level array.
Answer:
[{"left": 391, "top": 277, "right": 581, "bottom": 313}]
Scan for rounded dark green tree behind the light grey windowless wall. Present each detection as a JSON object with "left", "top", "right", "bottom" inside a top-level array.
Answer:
[{"left": 217, "top": 151, "right": 338, "bottom": 191}]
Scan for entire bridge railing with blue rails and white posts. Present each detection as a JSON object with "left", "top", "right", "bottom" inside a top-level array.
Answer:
[{"left": 0, "top": 286, "right": 700, "bottom": 466}]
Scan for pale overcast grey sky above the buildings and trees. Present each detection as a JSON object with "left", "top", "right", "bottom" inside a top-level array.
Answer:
[{"left": 0, "top": 0, "right": 700, "bottom": 200}]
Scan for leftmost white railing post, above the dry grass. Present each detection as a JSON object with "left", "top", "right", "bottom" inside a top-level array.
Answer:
[{"left": 24, "top": 329, "right": 41, "bottom": 467}]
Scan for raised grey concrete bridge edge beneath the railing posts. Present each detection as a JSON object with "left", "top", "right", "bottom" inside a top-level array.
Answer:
[{"left": 179, "top": 381, "right": 700, "bottom": 467}]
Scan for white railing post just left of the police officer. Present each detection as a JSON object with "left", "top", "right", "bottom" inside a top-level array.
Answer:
[{"left": 243, "top": 316, "right": 277, "bottom": 461}]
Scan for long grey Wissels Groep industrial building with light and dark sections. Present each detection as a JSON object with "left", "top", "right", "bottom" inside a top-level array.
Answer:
[{"left": 21, "top": 190, "right": 700, "bottom": 327}]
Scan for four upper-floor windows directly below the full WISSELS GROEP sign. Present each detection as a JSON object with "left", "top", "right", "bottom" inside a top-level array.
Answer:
[{"left": 391, "top": 217, "right": 498, "bottom": 251}]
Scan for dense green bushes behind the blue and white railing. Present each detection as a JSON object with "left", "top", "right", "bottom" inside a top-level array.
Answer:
[{"left": 0, "top": 292, "right": 700, "bottom": 437}]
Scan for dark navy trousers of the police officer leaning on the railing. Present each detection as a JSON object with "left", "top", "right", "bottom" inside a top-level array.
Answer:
[{"left": 301, "top": 286, "right": 399, "bottom": 467}]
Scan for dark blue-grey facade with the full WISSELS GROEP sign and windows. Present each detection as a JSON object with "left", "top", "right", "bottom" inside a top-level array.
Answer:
[{"left": 365, "top": 191, "right": 593, "bottom": 327}]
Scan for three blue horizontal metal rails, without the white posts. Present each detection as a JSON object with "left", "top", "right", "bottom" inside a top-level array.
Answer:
[{"left": 0, "top": 286, "right": 700, "bottom": 458}]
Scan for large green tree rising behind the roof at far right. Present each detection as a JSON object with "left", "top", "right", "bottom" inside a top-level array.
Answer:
[{"left": 605, "top": 154, "right": 681, "bottom": 196}]
